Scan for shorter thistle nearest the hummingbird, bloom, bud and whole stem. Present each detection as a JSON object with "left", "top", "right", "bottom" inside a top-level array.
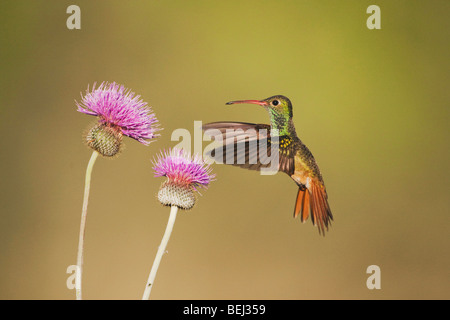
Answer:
[{"left": 142, "top": 149, "right": 215, "bottom": 300}]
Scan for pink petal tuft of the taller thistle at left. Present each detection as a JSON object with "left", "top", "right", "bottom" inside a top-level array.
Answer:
[{"left": 76, "top": 82, "right": 159, "bottom": 145}]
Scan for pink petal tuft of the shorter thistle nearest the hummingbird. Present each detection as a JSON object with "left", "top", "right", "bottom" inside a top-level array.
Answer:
[{"left": 153, "top": 148, "right": 215, "bottom": 190}]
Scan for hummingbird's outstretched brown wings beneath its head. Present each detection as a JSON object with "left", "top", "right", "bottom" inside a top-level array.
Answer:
[{"left": 203, "top": 122, "right": 295, "bottom": 175}]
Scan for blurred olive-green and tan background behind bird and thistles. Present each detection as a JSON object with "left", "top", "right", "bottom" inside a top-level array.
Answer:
[{"left": 0, "top": 0, "right": 450, "bottom": 299}]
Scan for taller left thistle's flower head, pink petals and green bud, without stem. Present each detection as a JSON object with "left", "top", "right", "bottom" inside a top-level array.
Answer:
[{"left": 76, "top": 82, "right": 159, "bottom": 157}]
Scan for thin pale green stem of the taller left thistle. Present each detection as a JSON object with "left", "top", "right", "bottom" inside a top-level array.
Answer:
[{"left": 75, "top": 151, "right": 99, "bottom": 300}]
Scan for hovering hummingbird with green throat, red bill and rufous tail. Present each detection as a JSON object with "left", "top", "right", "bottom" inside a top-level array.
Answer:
[{"left": 202, "top": 95, "right": 333, "bottom": 235}]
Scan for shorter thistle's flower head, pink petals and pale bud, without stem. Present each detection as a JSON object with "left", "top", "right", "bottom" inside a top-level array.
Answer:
[{"left": 153, "top": 149, "right": 215, "bottom": 210}]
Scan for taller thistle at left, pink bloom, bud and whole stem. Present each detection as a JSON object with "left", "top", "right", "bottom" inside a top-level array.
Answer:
[{"left": 75, "top": 82, "right": 159, "bottom": 300}]
